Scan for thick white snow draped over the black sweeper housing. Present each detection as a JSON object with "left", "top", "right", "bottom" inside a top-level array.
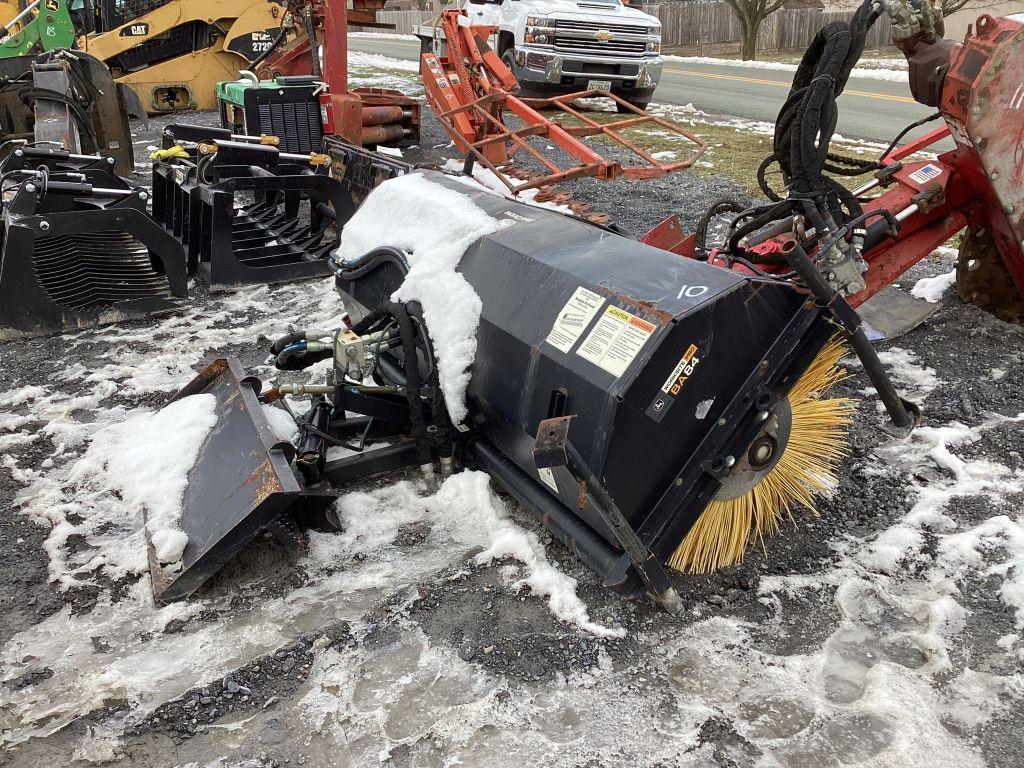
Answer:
[{"left": 337, "top": 173, "right": 500, "bottom": 424}]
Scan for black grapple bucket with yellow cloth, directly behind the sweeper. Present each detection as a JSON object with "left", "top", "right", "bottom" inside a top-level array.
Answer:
[{"left": 153, "top": 124, "right": 410, "bottom": 289}]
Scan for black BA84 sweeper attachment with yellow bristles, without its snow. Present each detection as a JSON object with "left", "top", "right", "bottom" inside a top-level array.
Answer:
[{"left": 148, "top": 171, "right": 847, "bottom": 604}]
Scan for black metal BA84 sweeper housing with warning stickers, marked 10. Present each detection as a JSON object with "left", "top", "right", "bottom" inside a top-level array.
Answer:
[{"left": 335, "top": 171, "right": 833, "bottom": 589}]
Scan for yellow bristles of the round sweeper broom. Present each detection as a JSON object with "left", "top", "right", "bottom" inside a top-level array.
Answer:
[{"left": 669, "top": 339, "right": 854, "bottom": 573}]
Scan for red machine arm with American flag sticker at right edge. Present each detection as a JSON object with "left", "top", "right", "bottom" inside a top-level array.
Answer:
[{"left": 711, "top": 15, "right": 1024, "bottom": 322}]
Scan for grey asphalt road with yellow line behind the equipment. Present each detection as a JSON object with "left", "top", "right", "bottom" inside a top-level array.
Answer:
[{"left": 348, "top": 37, "right": 934, "bottom": 143}]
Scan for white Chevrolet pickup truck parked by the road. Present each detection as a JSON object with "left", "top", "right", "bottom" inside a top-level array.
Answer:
[{"left": 416, "top": 0, "right": 663, "bottom": 108}]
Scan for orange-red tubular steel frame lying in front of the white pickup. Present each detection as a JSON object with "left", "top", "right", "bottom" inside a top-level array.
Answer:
[{"left": 420, "top": 10, "right": 707, "bottom": 193}]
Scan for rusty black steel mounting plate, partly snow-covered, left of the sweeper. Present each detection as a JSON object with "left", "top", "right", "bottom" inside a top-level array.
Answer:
[{"left": 146, "top": 357, "right": 301, "bottom": 603}]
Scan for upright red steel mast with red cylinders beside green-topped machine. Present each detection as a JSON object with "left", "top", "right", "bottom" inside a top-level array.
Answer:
[{"left": 255, "top": 0, "right": 420, "bottom": 145}]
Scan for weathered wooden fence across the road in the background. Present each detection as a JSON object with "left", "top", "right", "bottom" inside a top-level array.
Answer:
[{"left": 354, "top": 0, "right": 890, "bottom": 53}]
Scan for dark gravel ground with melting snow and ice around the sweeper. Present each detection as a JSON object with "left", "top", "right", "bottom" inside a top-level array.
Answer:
[{"left": 0, "top": 103, "right": 1024, "bottom": 768}]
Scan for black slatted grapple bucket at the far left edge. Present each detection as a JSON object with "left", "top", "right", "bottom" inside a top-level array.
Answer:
[{"left": 0, "top": 144, "right": 186, "bottom": 337}]
